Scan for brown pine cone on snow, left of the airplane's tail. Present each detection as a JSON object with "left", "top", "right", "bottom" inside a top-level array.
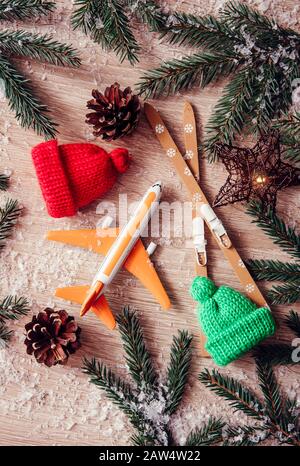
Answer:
[{"left": 24, "top": 308, "right": 81, "bottom": 367}]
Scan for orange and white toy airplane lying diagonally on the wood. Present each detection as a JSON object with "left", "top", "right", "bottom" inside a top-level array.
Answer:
[{"left": 47, "top": 182, "right": 170, "bottom": 329}]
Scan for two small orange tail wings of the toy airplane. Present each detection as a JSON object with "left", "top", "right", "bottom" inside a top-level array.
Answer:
[{"left": 55, "top": 285, "right": 116, "bottom": 330}]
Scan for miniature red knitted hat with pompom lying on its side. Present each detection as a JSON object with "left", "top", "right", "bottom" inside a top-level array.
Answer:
[{"left": 32, "top": 140, "right": 130, "bottom": 218}]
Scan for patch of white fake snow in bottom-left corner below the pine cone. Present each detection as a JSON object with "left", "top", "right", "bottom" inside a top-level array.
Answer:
[{"left": 0, "top": 329, "right": 130, "bottom": 445}]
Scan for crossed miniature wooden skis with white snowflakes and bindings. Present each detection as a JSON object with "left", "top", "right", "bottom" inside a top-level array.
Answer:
[{"left": 144, "top": 102, "right": 268, "bottom": 357}]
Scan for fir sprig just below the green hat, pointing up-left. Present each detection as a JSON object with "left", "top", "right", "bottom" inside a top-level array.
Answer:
[{"left": 199, "top": 369, "right": 263, "bottom": 420}]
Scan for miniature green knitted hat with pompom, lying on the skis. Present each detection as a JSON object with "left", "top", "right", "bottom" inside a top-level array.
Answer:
[{"left": 191, "top": 277, "right": 275, "bottom": 366}]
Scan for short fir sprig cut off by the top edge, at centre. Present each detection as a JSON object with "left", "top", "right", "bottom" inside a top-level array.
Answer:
[{"left": 126, "top": 0, "right": 168, "bottom": 31}]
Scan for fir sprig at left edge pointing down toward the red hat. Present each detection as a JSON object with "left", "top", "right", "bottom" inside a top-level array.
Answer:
[{"left": 0, "top": 56, "right": 57, "bottom": 139}]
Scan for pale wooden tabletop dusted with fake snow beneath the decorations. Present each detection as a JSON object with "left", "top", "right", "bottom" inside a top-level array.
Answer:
[{"left": 0, "top": 0, "right": 300, "bottom": 445}]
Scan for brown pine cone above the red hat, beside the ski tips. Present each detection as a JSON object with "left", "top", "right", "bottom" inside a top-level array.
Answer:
[{"left": 86, "top": 83, "right": 141, "bottom": 141}]
